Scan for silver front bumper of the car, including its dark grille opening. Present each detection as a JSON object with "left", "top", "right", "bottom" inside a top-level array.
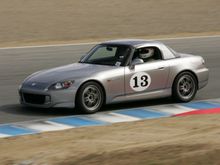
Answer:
[{"left": 19, "top": 87, "right": 76, "bottom": 108}]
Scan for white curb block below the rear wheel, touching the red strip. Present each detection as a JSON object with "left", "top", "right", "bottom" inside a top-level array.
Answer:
[{"left": 150, "top": 104, "right": 195, "bottom": 115}]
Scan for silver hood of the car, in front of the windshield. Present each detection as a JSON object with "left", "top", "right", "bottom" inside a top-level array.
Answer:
[{"left": 24, "top": 63, "right": 113, "bottom": 86}]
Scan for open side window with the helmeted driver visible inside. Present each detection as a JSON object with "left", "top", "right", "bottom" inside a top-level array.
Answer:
[{"left": 132, "top": 47, "right": 162, "bottom": 62}]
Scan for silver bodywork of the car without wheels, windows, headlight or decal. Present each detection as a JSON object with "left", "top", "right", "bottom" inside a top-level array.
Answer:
[{"left": 19, "top": 40, "right": 209, "bottom": 108}]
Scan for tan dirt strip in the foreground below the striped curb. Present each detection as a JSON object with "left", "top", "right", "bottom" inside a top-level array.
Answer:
[{"left": 0, "top": 115, "right": 220, "bottom": 165}]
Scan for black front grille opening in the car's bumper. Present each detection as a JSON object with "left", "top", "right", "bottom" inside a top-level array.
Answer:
[{"left": 22, "top": 93, "right": 46, "bottom": 104}]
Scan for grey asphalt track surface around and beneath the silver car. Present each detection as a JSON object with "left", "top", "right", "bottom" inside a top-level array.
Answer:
[{"left": 0, "top": 36, "right": 220, "bottom": 124}]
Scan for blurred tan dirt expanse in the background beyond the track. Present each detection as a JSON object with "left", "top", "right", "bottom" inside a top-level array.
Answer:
[{"left": 0, "top": 0, "right": 220, "bottom": 46}]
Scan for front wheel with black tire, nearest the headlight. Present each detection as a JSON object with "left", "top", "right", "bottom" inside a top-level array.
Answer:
[{"left": 76, "top": 81, "right": 104, "bottom": 114}]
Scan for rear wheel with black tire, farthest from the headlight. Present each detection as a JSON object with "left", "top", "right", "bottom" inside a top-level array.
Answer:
[{"left": 172, "top": 72, "right": 198, "bottom": 102}]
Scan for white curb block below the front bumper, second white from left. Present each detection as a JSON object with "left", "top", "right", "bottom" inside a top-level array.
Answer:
[{"left": 17, "top": 121, "right": 74, "bottom": 132}]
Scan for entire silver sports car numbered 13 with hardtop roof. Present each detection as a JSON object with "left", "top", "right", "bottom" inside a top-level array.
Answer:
[{"left": 19, "top": 40, "right": 209, "bottom": 113}]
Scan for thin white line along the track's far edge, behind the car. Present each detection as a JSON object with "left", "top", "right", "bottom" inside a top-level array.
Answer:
[{"left": 0, "top": 35, "right": 220, "bottom": 50}]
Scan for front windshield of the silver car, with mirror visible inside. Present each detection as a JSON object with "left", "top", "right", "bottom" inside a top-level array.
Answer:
[{"left": 80, "top": 44, "right": 131, "bottom": 66}]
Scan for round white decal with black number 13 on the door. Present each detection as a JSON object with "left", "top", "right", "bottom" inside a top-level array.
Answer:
[{"left": 130, "top": 72, "right": 151, "bottom": 91}]
